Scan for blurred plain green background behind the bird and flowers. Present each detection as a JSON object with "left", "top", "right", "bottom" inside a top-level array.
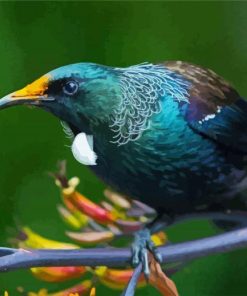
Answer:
[{"left": 0, "top": 1, "right": 247, "bottom": 296}]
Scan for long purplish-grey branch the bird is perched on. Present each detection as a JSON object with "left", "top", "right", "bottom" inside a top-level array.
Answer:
[{"left": 0, "top": 227, "right": 247, "bottom": 271}]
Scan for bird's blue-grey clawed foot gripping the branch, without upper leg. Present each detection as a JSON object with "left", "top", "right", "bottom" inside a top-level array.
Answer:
[{"left": 132, "top": 228, "right": 162, "bottom": 278}]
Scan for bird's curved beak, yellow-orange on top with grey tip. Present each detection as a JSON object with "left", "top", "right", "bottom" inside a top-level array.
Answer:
[{"left": 0, "top": 75, "right": 54, "bottom": 109}]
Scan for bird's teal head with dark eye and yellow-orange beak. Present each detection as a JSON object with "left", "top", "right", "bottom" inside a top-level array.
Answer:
[{"left": 0, "top": 63, "right": 119, "bottom": 164}]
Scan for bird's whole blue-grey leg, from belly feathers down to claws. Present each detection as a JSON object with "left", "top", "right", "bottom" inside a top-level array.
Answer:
[{"left": 132, "top": 215, "right": 170, "bottom": 278}]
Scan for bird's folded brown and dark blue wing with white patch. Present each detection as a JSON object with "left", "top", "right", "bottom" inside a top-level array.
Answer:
[{"left": 165, "top": 62, "right": 247, "bottom": 153}]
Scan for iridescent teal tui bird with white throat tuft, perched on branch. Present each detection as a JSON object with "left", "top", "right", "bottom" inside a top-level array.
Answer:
[{"left": 0, "top": 61, "right": 247, "bottom": 273}]
